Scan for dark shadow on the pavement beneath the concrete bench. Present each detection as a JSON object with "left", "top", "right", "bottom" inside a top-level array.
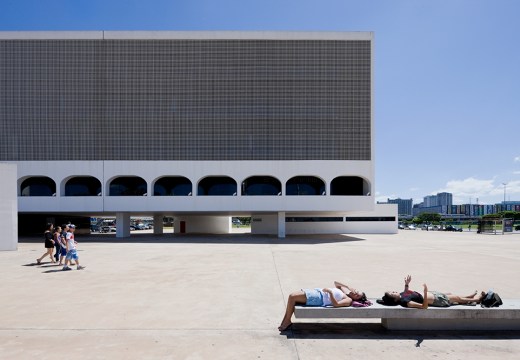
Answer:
[{"left": 280, "top": 323, "right": 520, "bottom": 338}]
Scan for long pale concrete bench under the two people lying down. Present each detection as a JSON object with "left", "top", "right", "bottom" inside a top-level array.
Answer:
[{"left": 294, "top": 300, "right": 520, "bottom": 330}]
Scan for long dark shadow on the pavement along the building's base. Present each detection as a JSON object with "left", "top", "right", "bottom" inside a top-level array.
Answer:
[{"left": 18, "top": 234, "right": 365, "bottom": 245}]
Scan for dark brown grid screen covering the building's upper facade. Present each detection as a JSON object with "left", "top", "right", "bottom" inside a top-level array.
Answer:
[{"left": 0, "top": 40, "right": 372, "bottom": 161}]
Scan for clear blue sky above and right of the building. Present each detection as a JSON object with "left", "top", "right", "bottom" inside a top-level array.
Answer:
[{"left": 0, "top": 0, "right": 520, "bottom": 204}]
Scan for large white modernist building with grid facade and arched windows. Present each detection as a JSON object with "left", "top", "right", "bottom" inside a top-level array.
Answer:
[{"left": 0, "top": 31, "right": 397, "bottom": 237}]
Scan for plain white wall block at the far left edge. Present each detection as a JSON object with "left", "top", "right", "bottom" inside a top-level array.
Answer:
[{"left": 0, "top": 164, "right": 18, "bottom": 251}]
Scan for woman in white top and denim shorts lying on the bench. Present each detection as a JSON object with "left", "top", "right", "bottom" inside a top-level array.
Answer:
[{"left": 278, "top": 281, "right": 367, "bottom": 331}]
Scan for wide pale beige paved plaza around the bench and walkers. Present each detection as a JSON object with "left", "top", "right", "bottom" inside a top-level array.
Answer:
[{"left": 0, "top": 230, "right": 520, "bottom": 360}]
